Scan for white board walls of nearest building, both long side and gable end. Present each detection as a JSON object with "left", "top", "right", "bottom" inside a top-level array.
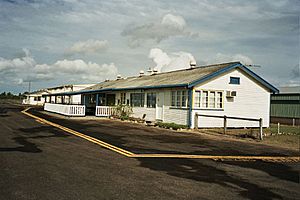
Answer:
[{"left": 112, "top": 69, "right": 270, "bottom": 128}]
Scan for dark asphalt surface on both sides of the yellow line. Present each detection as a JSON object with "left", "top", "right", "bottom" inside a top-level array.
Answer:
[{"left": 0, "top": 104, "right": 300, "bottom": 200}]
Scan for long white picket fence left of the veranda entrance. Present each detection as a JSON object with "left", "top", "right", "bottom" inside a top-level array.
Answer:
[{"left": 44, "top": 103, "right": 85, "bottom": 116}]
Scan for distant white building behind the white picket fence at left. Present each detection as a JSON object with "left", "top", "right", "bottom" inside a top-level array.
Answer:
[{"left": 22, "top": 84, "right": 93, "bottom": 105}]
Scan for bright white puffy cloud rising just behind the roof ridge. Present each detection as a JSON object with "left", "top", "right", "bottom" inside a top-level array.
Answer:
[{"left": 149, "top": 48, "right": 196, "bottom": 72}]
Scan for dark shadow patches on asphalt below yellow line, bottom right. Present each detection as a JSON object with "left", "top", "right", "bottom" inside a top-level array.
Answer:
[{"left": 138, "top": 158, "right": 298, "bottom": 200}]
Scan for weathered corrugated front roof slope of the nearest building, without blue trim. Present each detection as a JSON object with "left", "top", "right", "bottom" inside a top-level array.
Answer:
[{"left": 82, "top": 62, "right": 239, "bottom": 91}]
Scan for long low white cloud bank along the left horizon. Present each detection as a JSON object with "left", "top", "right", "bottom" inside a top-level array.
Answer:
[{"left": 0, "top": 49, "right": 118, "bottom": 84}]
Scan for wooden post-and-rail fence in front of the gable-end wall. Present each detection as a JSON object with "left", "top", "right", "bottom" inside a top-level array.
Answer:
[{"left": 195, "top": 113, "right": 263, "bottom": 140}]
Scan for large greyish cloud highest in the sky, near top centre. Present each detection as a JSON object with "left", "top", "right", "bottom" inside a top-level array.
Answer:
[{"left": 121, "top": 14, "right": 196, "bottom": 47}]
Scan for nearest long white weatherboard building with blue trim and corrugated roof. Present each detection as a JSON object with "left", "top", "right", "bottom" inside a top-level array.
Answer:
[{"left": 45, "top": 62, "right": 278, "bottom": 128}]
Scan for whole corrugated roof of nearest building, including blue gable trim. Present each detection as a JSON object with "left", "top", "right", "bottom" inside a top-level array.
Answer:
[{"left": 42, "top": 62, "right": 278, "bottom": 95}]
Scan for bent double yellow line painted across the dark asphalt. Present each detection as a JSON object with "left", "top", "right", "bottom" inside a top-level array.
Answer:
[{"left": 21, "top": 107, "right": 300, "bottom": 162}]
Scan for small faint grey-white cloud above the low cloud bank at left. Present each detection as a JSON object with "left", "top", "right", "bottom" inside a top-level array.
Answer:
[{"left": 66, "top": 39, "right": 108, "bottom": 55}]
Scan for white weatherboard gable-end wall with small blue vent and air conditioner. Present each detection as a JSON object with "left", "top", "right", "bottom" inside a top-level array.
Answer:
[{"left": 192, "top": 70, "right": 270, "bottom": 128}]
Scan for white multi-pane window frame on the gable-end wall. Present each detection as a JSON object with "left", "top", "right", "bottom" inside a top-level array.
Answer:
[{"left": 193, "top": 90, "right": 225, "bottom": 110}]
